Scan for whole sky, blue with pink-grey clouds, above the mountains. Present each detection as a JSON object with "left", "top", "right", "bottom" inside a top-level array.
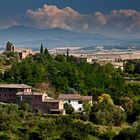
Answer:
[{"left": 0, "top": 0, "right": 140, "bottom": 35}]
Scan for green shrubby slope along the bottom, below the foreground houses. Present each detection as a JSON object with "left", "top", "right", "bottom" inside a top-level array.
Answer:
[{"left": 0, "top": 104, "right": 135, "bottom": 140}]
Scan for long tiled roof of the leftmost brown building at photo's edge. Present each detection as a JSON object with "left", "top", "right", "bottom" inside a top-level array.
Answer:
[{"left": 0, "top": 84, "right": 31, "bottom": 89}]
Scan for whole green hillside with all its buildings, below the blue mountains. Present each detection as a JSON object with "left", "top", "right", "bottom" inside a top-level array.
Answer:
[{"left": 0, "top": 42, "right": 140, "bottom": 140}]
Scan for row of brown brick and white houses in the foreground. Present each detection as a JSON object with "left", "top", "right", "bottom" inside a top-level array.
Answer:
[{"left": 0, "top": 84, "right": 92, "bottom": 114}]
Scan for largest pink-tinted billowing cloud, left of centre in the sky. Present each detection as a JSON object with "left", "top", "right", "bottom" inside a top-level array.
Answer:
[{"left": 27, "top": 4, "right": 80, "bottom": 29}]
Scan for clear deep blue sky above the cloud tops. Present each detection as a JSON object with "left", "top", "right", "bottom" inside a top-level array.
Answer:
[{"left": 0, "top": 0, "right": 140, "bottom": 17}]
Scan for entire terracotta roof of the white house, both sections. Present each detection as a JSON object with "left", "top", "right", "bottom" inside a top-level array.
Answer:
[{"left": 58, "top": 94, "right": 92, "bottom": 100}]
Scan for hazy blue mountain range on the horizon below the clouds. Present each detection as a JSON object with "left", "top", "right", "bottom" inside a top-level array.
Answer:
[{"left": 0, "top": 26, "right": 139, "bottom": 49}]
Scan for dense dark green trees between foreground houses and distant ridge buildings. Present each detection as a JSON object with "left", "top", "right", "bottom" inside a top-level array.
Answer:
[{"left": 1, "top": 49, "right": 133, "bottom": 99}]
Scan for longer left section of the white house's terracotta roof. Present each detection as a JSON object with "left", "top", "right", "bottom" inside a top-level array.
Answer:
[{"left": 58, "top": 94, "right": 82, "bottom": 100}]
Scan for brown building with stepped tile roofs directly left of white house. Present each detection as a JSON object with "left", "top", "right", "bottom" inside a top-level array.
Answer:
[{"left": 16, "top": 92, "right": 64, "bottom": 114}]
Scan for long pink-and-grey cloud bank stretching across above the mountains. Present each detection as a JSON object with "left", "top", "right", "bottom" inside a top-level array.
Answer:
[{"left": 0, "top": 4, "right": 140, "bottom": 34}]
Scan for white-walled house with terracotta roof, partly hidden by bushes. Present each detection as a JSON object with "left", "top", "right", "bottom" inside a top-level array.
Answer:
[{"left": 59, "top": 94, "right": 92, "bottom": 112}]
